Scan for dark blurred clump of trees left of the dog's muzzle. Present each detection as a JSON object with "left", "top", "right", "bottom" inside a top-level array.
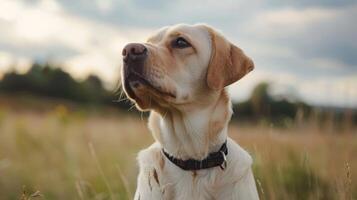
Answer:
[{"left": 0, "top": 63, "right": 130, "bottom": 108}]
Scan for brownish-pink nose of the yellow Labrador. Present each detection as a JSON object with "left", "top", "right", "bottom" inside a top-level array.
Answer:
[{"left": 122, "top": 43, "right": 148, "bottom": 62}]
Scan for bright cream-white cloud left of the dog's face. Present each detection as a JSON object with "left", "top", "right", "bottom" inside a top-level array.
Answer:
[{"left": 0, "top": 0, "right": 150, "bottom": 86}]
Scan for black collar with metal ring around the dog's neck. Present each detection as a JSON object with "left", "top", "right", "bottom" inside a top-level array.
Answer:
[{"left": 162, "top": 141, "right": 228, "bottom": 170}]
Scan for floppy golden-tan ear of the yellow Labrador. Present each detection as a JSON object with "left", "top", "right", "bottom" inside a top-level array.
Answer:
[{"left": 206, "top": 27, "right": 254, "bottom": 90}]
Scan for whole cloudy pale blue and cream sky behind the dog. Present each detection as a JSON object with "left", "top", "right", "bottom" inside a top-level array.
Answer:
[{"left": 0, "top": 0, "right": 357, "bottom": 108}]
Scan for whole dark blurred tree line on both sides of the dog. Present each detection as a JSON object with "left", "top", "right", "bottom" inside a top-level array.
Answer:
[{"left": 0, "top": 63, "right": 357, "bottom": 126}]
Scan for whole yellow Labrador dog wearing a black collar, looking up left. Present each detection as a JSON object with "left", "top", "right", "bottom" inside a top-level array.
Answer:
[{"left": 121, "top": 24, "right": 259, "bottom": 200}]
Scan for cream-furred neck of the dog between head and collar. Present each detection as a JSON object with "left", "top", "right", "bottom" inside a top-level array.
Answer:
[{"left": 149, "top": 90, "right": 232, "bottom": 160}]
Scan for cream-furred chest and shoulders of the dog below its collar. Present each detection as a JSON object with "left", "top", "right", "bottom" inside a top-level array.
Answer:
[{"left": 137, "top": 140, "right": 255, "bottom": 200}]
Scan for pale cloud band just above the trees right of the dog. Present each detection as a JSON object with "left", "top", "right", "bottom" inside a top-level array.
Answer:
[{"left": 229, "top": 71, "right": 357, "bottom": 108}]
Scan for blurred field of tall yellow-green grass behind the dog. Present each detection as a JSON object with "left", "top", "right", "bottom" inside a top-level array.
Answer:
[{"left": 0, "top": 99, "right": 357, "bottom": 200}]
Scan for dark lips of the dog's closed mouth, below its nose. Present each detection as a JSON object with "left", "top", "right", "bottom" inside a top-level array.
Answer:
[{"left": 124, "top": 71, "right": 176, "bottom": 100}]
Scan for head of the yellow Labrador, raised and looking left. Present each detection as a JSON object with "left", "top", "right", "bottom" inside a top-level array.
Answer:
[{"left": 122, "top": 25, "right": 254, "bottom": 110}]
